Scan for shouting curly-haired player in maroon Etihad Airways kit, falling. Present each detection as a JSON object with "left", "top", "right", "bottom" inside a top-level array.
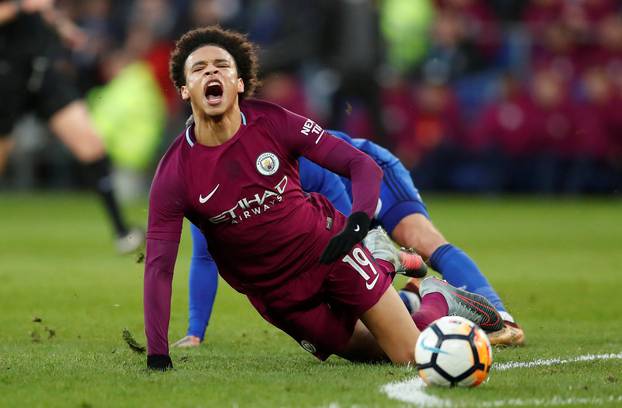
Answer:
[{"left": 144, "top": 27, "right": 503, "bottom": 370}]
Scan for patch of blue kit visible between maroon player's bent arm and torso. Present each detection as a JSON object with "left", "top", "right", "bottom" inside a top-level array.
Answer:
[{"left": 298, "top": 157, "right": 352, "bottom": 215}]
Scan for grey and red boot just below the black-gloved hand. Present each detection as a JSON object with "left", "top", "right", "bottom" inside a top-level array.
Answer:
[{"left": 363, "top": 227, "right": 428, "bottom": 277}]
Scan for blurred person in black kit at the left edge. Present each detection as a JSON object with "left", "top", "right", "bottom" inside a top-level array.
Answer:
[{"left": 0, "top": 0, "right": 144, "bottom": 253}]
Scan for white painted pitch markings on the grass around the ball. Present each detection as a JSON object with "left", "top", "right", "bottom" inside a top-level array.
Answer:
[{"left": 380, "top": 353, "right": 622, "bottom": 408}]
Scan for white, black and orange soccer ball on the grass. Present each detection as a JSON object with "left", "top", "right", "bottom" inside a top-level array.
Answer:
[{"left": 415, "top": 316, "right": 492, "bottom": 387}]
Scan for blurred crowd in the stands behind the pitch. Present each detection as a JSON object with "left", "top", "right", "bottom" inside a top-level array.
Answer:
[{"left": 4, "top": 0, "right": 622, "bottom": 194}]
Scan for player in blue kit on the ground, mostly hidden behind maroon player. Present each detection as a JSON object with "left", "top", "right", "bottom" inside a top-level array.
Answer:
[{"left": 173, "top": 130, "right": 524, "bottom": 347}]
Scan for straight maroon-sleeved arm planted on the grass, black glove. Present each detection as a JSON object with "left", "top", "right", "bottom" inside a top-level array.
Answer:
[{"left": 143, "top": 169, "right": 183, "bottom": 370}]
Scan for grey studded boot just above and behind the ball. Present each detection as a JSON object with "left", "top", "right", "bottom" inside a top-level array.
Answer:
[{"left": 419, "top": 277, "right": 503, "bottom": 332}]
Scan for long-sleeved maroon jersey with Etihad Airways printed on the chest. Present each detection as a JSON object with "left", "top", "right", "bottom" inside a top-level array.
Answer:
[{"left": 144, "top": 100, "right": 382, "bottom": 354}]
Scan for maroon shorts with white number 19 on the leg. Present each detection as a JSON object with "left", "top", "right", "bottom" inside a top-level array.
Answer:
[{"left": 249, "top": 244, "right": 394, "bottom": 360}]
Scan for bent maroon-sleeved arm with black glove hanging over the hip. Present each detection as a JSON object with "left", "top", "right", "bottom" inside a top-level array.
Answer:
[{"left": 281, "top": 110, "right": 383, "bottom": 263}]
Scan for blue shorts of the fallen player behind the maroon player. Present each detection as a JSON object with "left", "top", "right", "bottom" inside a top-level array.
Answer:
[{"left": 374, "top": 162, "right": 430, "bottom": 235}]
